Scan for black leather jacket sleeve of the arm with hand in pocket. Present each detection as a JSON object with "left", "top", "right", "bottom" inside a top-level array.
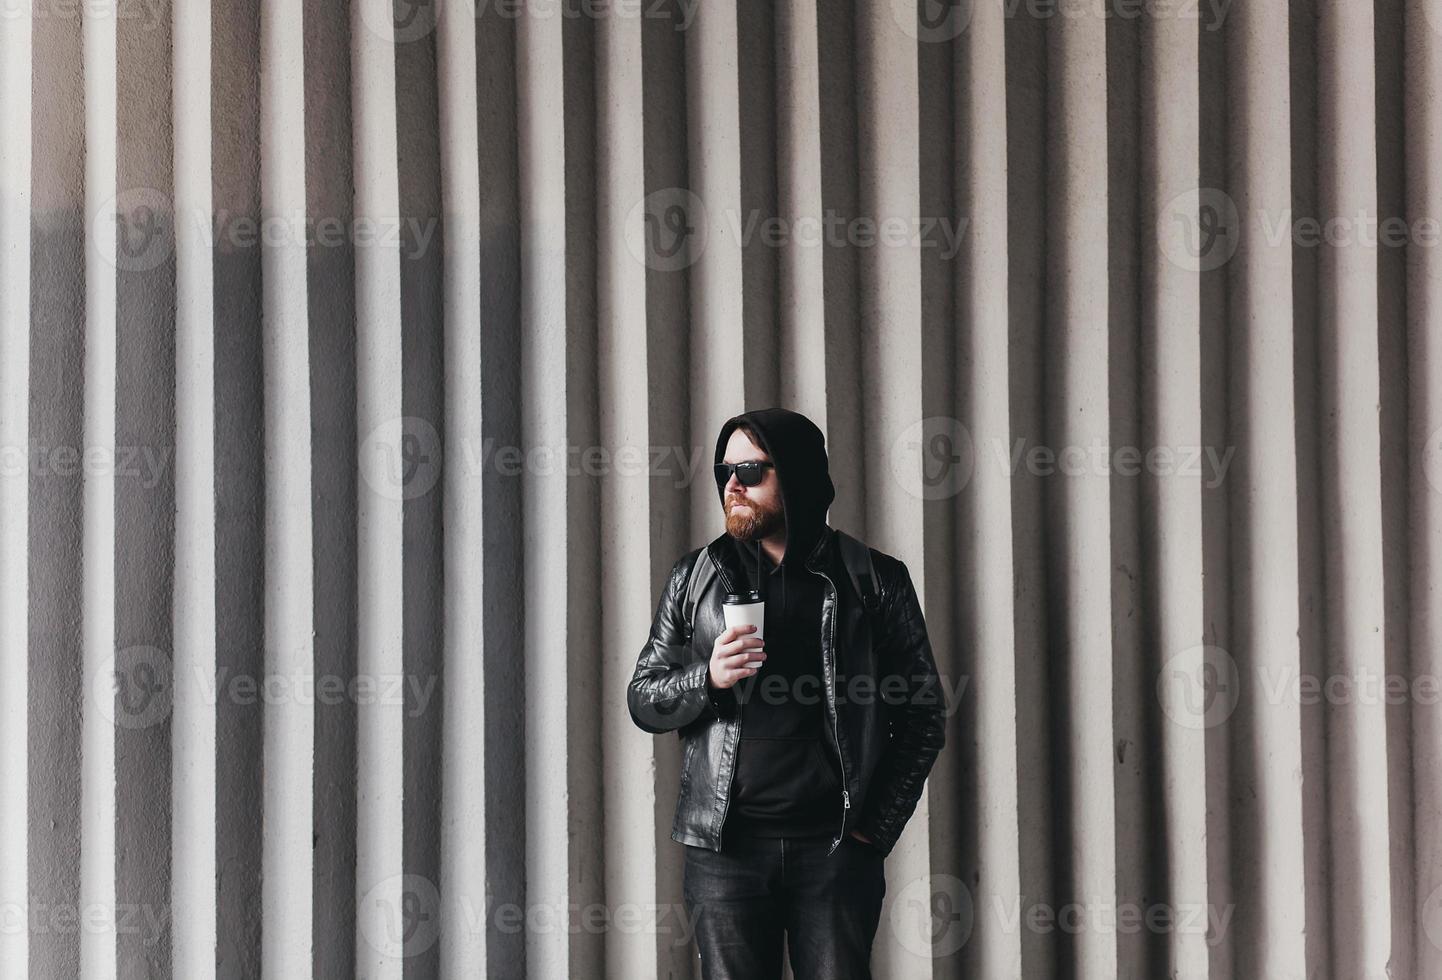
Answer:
[{"left": 858, "top": 562, "right": 946, "bottom": 853}]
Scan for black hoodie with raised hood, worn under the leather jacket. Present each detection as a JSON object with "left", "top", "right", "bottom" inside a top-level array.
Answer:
[{"left": 715, "top": 408, "right": 842, "bottom": 837}]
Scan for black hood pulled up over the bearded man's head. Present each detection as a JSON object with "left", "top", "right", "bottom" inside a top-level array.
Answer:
[{"left": 714, "top": 408, "right": 836, "bottom": 593}]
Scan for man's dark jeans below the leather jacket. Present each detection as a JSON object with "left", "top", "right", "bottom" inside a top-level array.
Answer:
[{"left": 682, "top": 836, "right": 887, "bottom": 980}]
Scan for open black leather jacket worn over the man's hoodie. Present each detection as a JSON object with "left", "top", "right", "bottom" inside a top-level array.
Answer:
[{"left": 626, "top": 527, "right": 946, "bottom": 855}]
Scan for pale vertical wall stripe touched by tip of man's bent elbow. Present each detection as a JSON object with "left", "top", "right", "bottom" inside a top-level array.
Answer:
[{"left": 596, "top": 10, "right": 654, "bottom": 977}]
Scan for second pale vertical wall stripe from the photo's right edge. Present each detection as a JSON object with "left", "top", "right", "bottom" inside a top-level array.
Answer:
[{"left": 1318, "top": 0, "right": 1392, "bottom": 977}]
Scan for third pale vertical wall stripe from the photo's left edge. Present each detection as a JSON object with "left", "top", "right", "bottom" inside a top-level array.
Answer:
[{"left": 170, "top": 3, "right": 216, "bottom": 980}]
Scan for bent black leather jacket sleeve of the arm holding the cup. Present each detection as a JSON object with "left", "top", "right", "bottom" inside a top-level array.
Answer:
[{"left": 626, "top": 553, "right": 734, "bottom": 735}]
